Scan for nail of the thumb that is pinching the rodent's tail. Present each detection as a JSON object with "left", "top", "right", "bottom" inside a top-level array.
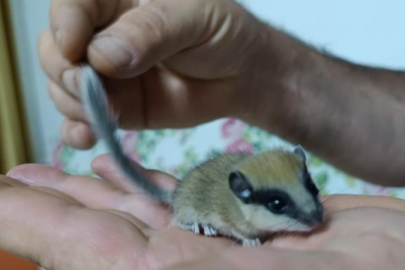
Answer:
[{"left": 92, "top": 36, "right": 135, "bottom": 67}]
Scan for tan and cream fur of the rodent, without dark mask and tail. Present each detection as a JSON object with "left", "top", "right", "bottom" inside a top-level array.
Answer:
[{"left": 173, "top": 150, "right": 316, "bottom": 243}]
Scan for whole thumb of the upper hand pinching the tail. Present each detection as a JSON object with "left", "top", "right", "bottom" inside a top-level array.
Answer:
[{"left": 88, "top": 0, "right": 211, "bottom": 78}]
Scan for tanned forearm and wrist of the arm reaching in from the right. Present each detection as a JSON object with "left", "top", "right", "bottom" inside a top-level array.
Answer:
[{"left": 240, "top": 24, "right": 405, "bottom": 185}]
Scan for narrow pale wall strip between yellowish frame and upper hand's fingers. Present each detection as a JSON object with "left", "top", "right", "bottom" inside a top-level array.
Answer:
[{"left": 10, "top": 0, "right": 57, "bottom": 163}]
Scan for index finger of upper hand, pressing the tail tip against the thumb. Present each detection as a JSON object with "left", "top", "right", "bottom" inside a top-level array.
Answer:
[{"left": 50, "top": 0, "right": 132, "bottom": 62}]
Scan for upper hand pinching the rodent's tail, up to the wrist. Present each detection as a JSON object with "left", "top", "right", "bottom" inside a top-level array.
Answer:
[{"left": 39, "top": 0, "right": 286, "bottom": 149}]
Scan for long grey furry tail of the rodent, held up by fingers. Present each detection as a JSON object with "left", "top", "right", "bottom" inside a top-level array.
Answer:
[{"left": 81, "top": 65, "right": 171, "bottom": 204}]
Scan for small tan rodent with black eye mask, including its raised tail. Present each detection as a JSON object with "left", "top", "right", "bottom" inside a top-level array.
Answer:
[{"left": 81, "top": 65, "right": 323, "bottom": 246}]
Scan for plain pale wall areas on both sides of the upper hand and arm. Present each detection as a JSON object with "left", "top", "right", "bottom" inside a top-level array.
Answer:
[{"left": 11, "top": 0, "right": 405, "bottom": 162}]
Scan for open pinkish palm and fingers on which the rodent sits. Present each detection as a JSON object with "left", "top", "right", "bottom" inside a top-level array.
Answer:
[{"left": 0, "top": 156, "right": 405, "bottom": 270}]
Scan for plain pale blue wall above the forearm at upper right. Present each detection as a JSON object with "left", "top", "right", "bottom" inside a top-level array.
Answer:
[{"left": 240, "top": 0, "right": 405, "bottom": 69}]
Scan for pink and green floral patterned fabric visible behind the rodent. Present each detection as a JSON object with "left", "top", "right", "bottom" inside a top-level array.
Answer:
[{"left": 51, "top": 119, "right": 405, "bottom": 198}]
